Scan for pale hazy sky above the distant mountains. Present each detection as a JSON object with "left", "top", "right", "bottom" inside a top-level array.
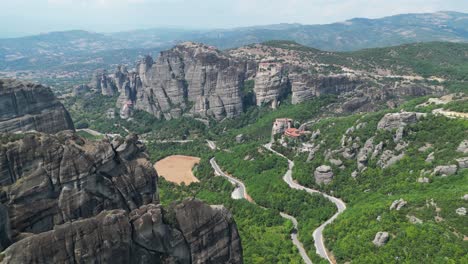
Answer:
[{"left": 0, "top": 0, "right": 468, "bottom": 37}]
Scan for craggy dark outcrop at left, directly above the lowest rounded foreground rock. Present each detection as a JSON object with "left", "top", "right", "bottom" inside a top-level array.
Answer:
[{"left": 0, "top": 132, "right": 157, "bottom": 233}]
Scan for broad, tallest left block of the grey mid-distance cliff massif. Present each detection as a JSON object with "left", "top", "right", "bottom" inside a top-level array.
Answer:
[{"left": 122, "top": 43, "right": 252, "bottom": 120}]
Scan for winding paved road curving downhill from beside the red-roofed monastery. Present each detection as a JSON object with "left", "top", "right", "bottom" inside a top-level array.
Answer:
[{"left": 264, "top": 143, "right": 346, "bottom": 263}]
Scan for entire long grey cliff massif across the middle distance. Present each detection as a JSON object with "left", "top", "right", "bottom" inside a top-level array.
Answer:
[{"left": 84, "top": 42, "right": 443, "bottom": 120}]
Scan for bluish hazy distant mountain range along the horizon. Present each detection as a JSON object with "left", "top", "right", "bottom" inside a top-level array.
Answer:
[{"left": 0, "top": 12, "right": 468, "bottom": 75}]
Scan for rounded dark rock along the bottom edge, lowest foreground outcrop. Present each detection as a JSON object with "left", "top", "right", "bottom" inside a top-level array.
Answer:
[{"left": 3, "top": 200, "right": 242, "bottom": 264}]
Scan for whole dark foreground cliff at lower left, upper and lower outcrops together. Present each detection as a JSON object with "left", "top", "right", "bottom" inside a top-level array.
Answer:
[{"left": 0, "top": 131, "right": 242, "bottom": 263}]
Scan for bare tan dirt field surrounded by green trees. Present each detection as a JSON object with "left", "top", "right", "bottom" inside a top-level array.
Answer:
[{"left": 154, "top": 155, "right": 200, "bottom": 185}]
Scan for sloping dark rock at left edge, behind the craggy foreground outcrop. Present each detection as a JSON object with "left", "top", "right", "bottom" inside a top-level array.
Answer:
[{"left": 0, "top": 79, "right": 74, "bottom": 133}]
